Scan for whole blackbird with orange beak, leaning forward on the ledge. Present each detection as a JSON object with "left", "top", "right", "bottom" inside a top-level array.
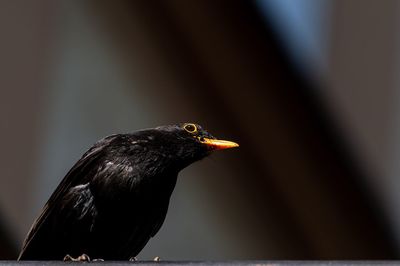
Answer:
[{"left": 18, "top": 123, "right": 239, "bottom": 260}]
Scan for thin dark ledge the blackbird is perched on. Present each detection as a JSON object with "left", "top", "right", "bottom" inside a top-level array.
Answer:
[{"left": 0, "top": 260, "right": 400, "bottom": 266}]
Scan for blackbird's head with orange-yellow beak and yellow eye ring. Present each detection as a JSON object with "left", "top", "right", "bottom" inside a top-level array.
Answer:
[{"left": 138, "top": 123, "right": 239, "bottom": 168}]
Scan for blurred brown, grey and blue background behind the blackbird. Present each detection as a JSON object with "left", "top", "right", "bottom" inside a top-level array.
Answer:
[{"left": 0, "top": 0, "right": 400, "bottom": 260}]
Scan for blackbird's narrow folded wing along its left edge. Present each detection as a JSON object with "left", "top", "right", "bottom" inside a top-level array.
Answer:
[{"left": 18, "top": 135, "right": 119, "bottom": 259}]
